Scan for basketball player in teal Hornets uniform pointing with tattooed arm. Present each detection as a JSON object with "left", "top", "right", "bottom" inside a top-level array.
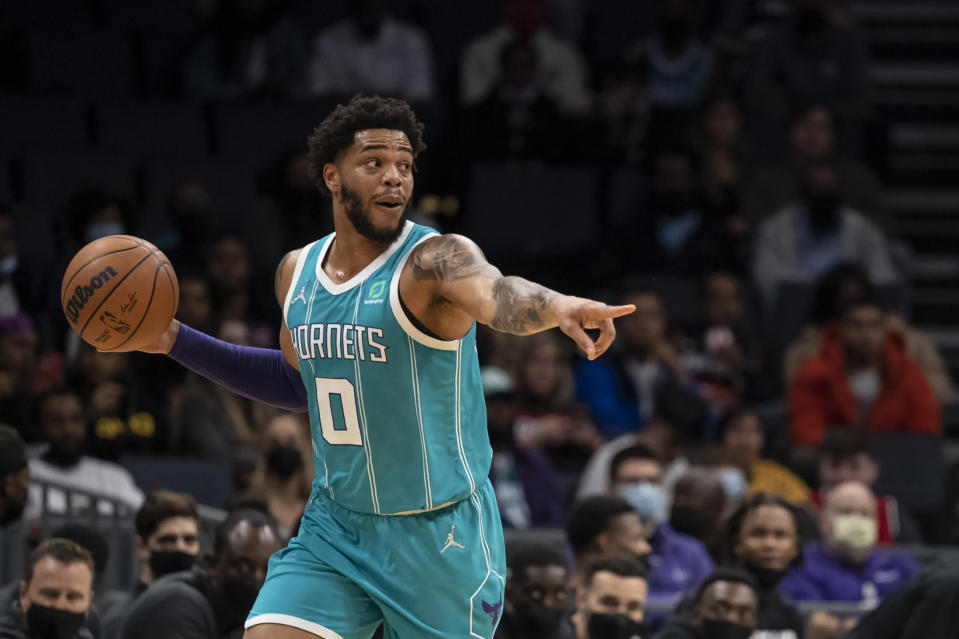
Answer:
[{"left": 129, "top": 97, "right": 633, "bottom": 639}]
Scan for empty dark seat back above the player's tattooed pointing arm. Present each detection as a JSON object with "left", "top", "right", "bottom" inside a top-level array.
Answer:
[{"left": 465, "top": 165, "right": 598, "bottom": 256}]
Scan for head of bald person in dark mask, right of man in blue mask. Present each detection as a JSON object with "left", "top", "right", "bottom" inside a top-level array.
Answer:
[{"left": 669, "top": 467, "right": 728, "bottom": 549}]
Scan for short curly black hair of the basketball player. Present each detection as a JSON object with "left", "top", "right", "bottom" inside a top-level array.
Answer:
[{"left": 307, "top": 95, "right": 426, "bottom": 195}]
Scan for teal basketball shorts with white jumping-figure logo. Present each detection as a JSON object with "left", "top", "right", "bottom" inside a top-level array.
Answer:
[{"left": 246, "top": 480, "right": 506, "bottom": 639}]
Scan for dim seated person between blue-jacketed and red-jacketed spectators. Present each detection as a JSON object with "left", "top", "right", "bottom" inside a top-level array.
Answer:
[{"left": 681, "top": 271, "right": 762, "bottom": 412}]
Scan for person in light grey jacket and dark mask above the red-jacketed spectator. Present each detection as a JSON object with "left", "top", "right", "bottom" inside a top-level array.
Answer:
[{"left": 752, "top": 161, "right": 900, "bottom": 305}]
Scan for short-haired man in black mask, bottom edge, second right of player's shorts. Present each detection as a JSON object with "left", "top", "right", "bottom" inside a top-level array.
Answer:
[{"left": 573, "top": 556, "right": 646, "bottom": 639}]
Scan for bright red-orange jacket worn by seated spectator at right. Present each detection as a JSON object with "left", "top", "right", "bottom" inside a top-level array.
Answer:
[{"left": 789, "top": 326, "right": 942, "bottom": 444}]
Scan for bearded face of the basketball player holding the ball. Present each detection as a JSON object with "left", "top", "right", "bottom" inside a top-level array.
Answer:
[{"left": 328, "top": 129, "right": 413, "bottom": 243}]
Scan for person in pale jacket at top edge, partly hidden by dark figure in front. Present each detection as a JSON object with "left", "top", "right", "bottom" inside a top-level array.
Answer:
[{"left": 460, "top": 0, "right": 589, "bottom": 114}]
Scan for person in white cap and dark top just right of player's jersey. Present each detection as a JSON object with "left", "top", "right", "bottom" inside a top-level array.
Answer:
[{"left": 481, "top": 366, "right": 565, "bottom": 528}]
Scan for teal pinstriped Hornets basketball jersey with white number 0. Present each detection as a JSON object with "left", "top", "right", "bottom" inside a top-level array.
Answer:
[{"left": 283, "top": 222, "right": 492, "bottom": 515}]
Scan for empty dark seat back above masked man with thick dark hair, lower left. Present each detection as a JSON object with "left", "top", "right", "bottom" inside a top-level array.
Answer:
[{"left": 120, "top": 455, "right": 232, "bottom": 507}]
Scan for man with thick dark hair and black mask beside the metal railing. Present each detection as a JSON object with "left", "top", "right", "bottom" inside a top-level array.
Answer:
[{"left": 97, "top": 490, "right": 200, "bottom": 639}]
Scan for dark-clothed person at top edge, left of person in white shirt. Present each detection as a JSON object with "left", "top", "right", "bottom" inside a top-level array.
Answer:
[{"left": 183, "top": 0, "right": 307, "bottom": 100}]
